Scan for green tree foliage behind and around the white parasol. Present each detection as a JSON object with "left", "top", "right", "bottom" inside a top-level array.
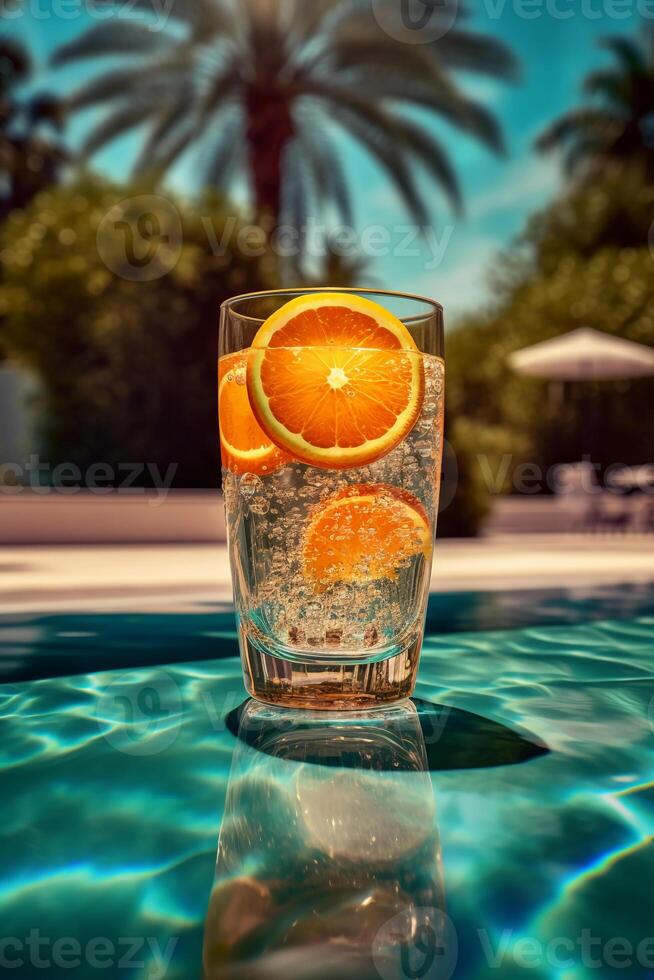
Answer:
[{"left": 448, "top": 168, "right": 654, "bottom": 478}]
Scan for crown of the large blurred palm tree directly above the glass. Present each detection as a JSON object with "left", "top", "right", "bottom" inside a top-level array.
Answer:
[{"left": 54, "top": 0, "right": 516, "bottom": 225}]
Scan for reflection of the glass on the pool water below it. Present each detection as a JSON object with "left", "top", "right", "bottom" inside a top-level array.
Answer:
[{"left": 204, "top": 702, "right": 450, "bottom": 980}]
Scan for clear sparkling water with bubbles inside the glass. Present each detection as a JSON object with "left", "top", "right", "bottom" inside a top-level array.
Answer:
[{"left": 223, "top": 353, "right": 444, "bottom": 661}]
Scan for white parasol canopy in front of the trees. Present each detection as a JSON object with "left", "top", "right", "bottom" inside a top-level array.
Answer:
[{"left": 509, "top": 327, "right": 654, "bottom": 381}]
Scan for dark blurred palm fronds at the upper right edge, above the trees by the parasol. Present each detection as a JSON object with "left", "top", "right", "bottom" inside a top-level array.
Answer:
[{"left": 536, "top": 27, "right": 654, "bottom": 177}]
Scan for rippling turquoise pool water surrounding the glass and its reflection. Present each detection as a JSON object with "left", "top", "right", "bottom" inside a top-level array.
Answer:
[{"left": 0, "top": 587, "right": 654, "bottom": 980}]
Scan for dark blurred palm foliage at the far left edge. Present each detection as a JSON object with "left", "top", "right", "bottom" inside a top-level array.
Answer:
[{"left": 0, "top": 37, "right": 66, "bottom": 216}]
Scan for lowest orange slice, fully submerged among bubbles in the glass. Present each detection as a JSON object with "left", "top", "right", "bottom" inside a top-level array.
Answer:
[{"left": 302, "top": 484, "right": 432, "bottom": 587}]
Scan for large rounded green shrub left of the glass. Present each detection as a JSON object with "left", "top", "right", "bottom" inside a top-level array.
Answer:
[{"left": 0, "top": 178, "right": 274, "bottom": 487}]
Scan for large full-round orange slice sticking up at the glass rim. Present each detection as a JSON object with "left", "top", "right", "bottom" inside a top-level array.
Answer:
[{"left": 247, "top": 293, "right": 425, "bottom": 469}]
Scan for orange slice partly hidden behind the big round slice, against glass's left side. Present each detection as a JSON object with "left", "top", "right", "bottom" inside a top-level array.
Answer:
[{"left": 218, "top": 351, "right": 288, "bottom": 475}]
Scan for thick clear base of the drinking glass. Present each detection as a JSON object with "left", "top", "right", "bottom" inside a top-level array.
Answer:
[{"left": 240, "top": 629, "right": 422, "bottom": 711}]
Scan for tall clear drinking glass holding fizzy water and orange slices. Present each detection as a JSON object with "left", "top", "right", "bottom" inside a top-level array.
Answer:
[{"left": 219, "top": 289, "right": 444, "bottom": 710}]
